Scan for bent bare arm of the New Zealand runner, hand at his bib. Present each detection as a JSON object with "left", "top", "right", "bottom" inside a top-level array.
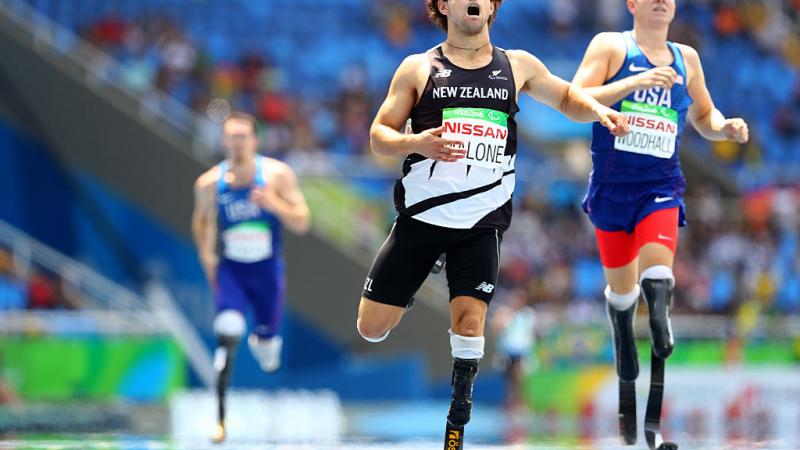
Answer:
[{"left": 369, "top": 55, "right": 464, "bottom": 161}]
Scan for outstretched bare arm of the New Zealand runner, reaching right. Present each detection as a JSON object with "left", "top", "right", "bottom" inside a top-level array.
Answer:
[{"left": 509, "top": 50, "right": 629, "bottom": 136}]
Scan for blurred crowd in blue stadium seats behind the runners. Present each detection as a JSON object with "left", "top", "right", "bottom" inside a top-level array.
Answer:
[{"left": 14, "top": 0, "right": 800, "bottom": 324}]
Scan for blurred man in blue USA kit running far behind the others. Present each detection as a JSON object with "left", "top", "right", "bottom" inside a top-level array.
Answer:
[{"left": 192, "top": 113, "right": 310, "bottom": 442}]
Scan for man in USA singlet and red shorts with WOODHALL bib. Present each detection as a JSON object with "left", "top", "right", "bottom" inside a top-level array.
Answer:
[{"left": 573, "top": 0, "right": 748, "bottom": 447}]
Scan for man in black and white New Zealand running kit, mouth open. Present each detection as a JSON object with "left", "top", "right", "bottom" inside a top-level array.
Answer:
[{"left": 357, "top": 0, "right": 627, "bottom": 447}]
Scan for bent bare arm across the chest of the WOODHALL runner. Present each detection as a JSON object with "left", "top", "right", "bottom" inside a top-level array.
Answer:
[{"left": 572, "top": 33, "right": 677, "bottom": 106}]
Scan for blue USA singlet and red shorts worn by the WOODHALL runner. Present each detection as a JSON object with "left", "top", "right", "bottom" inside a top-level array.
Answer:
[{"left": 582, "top": 31, "right": 692, "bottom": 268}]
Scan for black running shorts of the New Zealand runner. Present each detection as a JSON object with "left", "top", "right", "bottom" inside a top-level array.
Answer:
[{"left": 361, "top": 215, "right": 502, "bottom": 307}]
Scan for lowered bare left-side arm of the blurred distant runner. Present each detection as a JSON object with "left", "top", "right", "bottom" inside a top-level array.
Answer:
[{"left": 192, "top": 168, "right": 219, "bottom": 286}]
